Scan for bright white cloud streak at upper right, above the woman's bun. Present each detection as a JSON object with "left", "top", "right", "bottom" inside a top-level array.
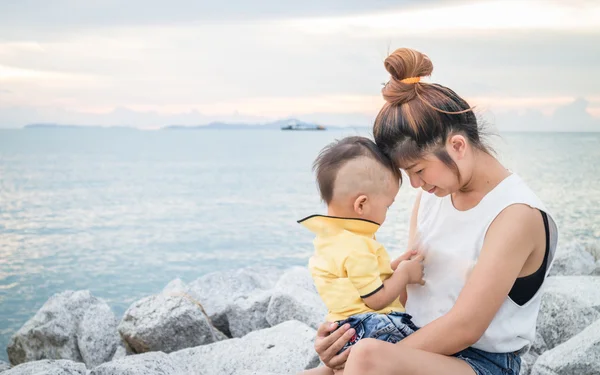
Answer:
[{"left": 284, "top": 0, "right": 600, "bottom": 37}]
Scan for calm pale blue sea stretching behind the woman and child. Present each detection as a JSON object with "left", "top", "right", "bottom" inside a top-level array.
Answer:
[{"left": 0, "top": 129, "right": 600, "bottom": 360}]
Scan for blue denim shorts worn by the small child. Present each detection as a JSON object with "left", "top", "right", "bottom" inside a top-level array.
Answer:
[{"left": 338, "top": 312, "right": 418, "bottom": 354}]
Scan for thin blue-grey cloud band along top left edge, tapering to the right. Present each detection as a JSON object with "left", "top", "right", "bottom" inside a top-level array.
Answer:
[{"left": 0, "top": 0, "right": 441, "bottom": 31}]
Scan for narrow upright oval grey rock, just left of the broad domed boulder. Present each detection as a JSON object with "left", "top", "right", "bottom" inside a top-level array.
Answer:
[{"left": 77, "top": 304, "right": 121, "bottom": 368}]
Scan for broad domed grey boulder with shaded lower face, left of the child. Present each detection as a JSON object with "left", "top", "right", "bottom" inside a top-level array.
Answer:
[{"left": 118, "top": 294, "right": 219, "bottom": 353}]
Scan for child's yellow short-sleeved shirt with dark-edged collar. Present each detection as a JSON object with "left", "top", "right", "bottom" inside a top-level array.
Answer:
[{"left": 298, "top": 215, "right": 404, "bottom": 322}]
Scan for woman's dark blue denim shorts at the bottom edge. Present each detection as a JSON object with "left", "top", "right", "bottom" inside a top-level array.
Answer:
[{"left": 454, "top": 348, "right": 521, "bottom": 375}]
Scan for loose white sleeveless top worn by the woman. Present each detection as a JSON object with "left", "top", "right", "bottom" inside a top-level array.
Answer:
[{"left": 406, "top": 174, "right": 558, "bottom": 353}]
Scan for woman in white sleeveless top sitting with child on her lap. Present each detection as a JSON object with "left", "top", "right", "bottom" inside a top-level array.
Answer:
[{"left": 309, "top": 48, "right": 557, "bottom": 375}]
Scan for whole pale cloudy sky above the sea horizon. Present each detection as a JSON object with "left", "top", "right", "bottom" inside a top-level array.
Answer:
[{"left": 0, "top": 0, "right": 600, "bottom": 131}]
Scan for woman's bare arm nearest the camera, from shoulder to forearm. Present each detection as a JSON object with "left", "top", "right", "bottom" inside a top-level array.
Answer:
[{"left": 398, "top": 204, "right": 543, "bottom": 355}]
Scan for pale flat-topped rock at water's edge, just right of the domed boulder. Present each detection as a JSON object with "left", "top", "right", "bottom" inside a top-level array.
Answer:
[{"left": 163, "top": 267, "right": 282, "bottom": 337}]
